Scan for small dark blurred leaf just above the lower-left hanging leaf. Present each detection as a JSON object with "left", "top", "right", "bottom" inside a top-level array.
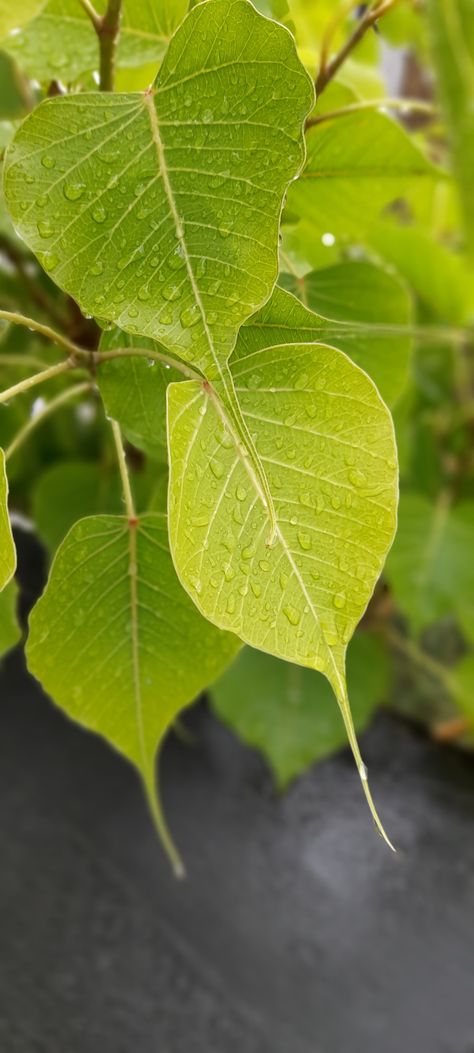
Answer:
[{"left": 33, "top": 460, "right": 123, "bottom": 552}]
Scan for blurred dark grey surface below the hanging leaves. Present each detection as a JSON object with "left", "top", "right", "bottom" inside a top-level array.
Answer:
[{"left": 0, "top": 539, "right": 474, "bottom": 1053}]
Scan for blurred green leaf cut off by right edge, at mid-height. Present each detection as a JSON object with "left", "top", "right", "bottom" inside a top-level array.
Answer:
[{"left": 386, "top": 493, "right": 474, "bottom": 641}]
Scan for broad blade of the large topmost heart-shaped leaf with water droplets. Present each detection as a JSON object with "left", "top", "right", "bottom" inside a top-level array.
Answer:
[{"left": 5, "top": 0, "right": 313, "bottom": 379}]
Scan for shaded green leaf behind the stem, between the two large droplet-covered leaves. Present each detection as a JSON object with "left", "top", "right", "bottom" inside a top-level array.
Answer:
[{"left": 97, "top": 327, "right": 181, "bottom": 460}]
